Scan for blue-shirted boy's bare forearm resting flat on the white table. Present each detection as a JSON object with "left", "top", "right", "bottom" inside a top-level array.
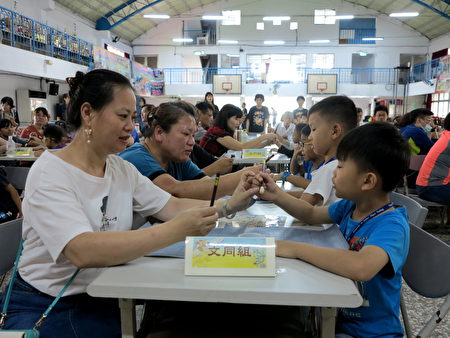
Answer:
[{"left": 276, "top": 242, "right": 389, "bottom": 282}]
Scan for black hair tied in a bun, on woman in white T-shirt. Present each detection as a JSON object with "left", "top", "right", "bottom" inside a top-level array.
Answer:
[{"left": 66, "top": 69, "right": 133, "bottom": 129}]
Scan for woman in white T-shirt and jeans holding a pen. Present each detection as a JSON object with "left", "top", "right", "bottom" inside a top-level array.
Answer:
[{"left": 0, "top": 69, "right": 257, "bottom": 337}]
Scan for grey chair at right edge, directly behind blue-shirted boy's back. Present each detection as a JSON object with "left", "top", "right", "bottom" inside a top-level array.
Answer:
[{"left": 400, "top": 223, "right": 450, "bottom": 338}]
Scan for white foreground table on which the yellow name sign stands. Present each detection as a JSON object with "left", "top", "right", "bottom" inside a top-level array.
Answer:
[{"left": 87, "top": 257, "right": 362, "bottom": 337}]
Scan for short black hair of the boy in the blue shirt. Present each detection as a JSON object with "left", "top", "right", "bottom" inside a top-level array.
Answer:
[{"left": 336, "top": 122, "right": 410, "bottom": 192}]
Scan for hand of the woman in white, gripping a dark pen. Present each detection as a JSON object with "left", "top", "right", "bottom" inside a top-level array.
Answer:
[{"left": 169, "top": 207, "right": 218, "bottom": 238}]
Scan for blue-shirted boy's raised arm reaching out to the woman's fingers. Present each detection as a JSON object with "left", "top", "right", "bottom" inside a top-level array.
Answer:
[{"left": 253, "top": 172, "right": 333, "bottom": 224}]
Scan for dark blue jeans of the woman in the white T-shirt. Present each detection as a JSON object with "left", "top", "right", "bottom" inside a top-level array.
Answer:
[{"left": 2, "top": 273, "right": 121, "bottom": 338}]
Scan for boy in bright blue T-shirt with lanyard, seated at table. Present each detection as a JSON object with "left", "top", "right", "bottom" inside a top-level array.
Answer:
[{"left": 253, "top": 122, "right": 410, "bottom": 337}]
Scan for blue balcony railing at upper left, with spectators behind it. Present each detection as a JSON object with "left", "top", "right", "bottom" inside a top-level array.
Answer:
[{"left": 0, "top": 6, "right": 93, "bottom": 66}]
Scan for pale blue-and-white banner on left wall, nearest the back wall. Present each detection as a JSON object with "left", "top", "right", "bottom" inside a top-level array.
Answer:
[{"left": 133, "top": 61, "right": 164, "bottom": 96}]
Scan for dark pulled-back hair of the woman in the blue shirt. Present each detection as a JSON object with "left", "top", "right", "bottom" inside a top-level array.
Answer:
[{"left": 144, "top": 100, "right": 195, "bottom": 137}]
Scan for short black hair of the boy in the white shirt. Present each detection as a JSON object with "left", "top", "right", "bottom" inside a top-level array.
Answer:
[{"left": 308, "top": 96, "right": 358, "bottom": 134}]
